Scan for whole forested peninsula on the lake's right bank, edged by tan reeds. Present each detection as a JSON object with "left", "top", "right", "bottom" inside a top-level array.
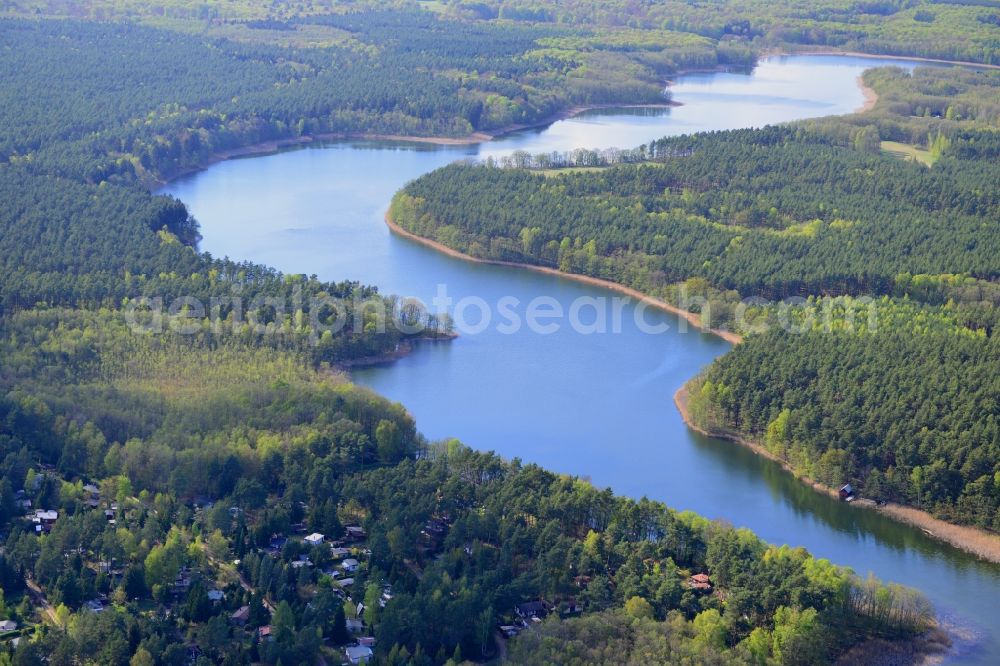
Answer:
[{"left": 392, "top": 68, "right": 1000, "bottom": 530}]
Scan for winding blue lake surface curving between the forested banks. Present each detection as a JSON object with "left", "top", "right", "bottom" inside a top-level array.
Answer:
[{"left": 163, "top": 56, "right": 1000, "bottom": 664}]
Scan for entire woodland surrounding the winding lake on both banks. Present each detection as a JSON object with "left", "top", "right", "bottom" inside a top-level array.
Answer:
[{"left": 0, "top": 0, "right": 1000, "bottom": 666}]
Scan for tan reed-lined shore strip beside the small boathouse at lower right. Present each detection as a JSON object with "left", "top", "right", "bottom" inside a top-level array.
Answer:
[{"left": 674, "top": 380, "right": 1000, "bottom": 564}]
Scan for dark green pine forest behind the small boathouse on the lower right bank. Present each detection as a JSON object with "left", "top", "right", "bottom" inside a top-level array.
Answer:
[{"left": 689, "top": 298, "right": 1000, "bottom": 531}]
